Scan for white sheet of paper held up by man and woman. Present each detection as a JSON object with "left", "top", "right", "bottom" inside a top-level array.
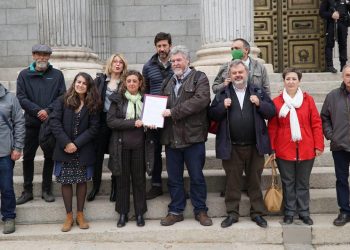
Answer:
[{"left": 141, "top": 94, "right": 168, "bottom": 128}]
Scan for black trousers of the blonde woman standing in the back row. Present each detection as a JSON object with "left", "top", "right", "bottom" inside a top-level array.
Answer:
[{"left": 92, "top": 119, "right": 111, "bottom": 189}]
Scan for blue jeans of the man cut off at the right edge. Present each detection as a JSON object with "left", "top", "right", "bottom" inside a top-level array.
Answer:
[{"left": 332, "top": 150, "right": 350, "bottom": 215}]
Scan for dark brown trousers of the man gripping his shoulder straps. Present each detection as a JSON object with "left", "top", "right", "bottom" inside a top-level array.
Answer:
[{"left": 222, "top": 145, "right": 265, "bottom": 219}]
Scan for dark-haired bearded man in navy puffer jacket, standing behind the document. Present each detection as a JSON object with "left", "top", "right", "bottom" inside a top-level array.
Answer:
[{"left": 142, "top": 32, "right": 173, "bottom": 200}]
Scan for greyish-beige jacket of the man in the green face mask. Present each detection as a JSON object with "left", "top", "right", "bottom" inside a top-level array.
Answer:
[{"left": 212, "top": 57, "right": 271, "bottom": 97}]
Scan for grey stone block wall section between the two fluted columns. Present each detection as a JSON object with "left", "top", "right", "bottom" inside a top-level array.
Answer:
[{"left": 110, "top": 0, "right": 201, "bottom": 64}]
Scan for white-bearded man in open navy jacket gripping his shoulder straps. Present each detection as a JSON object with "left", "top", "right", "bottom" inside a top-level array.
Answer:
[{"left": 209, "top": 59, "right": 276, "bottom": 228}]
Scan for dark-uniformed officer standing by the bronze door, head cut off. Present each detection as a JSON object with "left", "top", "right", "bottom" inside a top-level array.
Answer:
[{"left": 320, "top": 0, "right": 350, "bottom": 73}]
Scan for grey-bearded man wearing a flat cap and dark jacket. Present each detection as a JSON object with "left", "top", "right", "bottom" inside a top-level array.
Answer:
[{"left": 16, "top": 44, "right": 66, "bottom": 205}]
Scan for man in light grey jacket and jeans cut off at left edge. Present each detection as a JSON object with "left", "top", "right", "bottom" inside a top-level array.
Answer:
[{"left": 0, "top": 83, "right": 25, "bottom": 234}]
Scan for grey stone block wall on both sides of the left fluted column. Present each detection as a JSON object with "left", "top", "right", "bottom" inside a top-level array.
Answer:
[{"left": 0, "top": 0, "right": 201, "bottom": 80}]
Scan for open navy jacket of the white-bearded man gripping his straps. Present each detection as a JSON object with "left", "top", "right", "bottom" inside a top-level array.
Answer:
[{"left": 209, "top": 84, "right": 276, "bottom": 160}]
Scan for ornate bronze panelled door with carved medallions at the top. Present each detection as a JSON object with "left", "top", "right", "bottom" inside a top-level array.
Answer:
[{"left": 254, "top": 0, "right": 325, "bottom": 72}]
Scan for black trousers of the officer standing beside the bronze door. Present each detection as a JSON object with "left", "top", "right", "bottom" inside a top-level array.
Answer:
[{"left": 325, "top": 21, "right": 348, "bottom": 67}]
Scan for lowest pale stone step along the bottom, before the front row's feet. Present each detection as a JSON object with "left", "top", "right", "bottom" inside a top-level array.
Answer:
[{"left": 0, "top": 214, "right": 350, "bottom": 250}]
